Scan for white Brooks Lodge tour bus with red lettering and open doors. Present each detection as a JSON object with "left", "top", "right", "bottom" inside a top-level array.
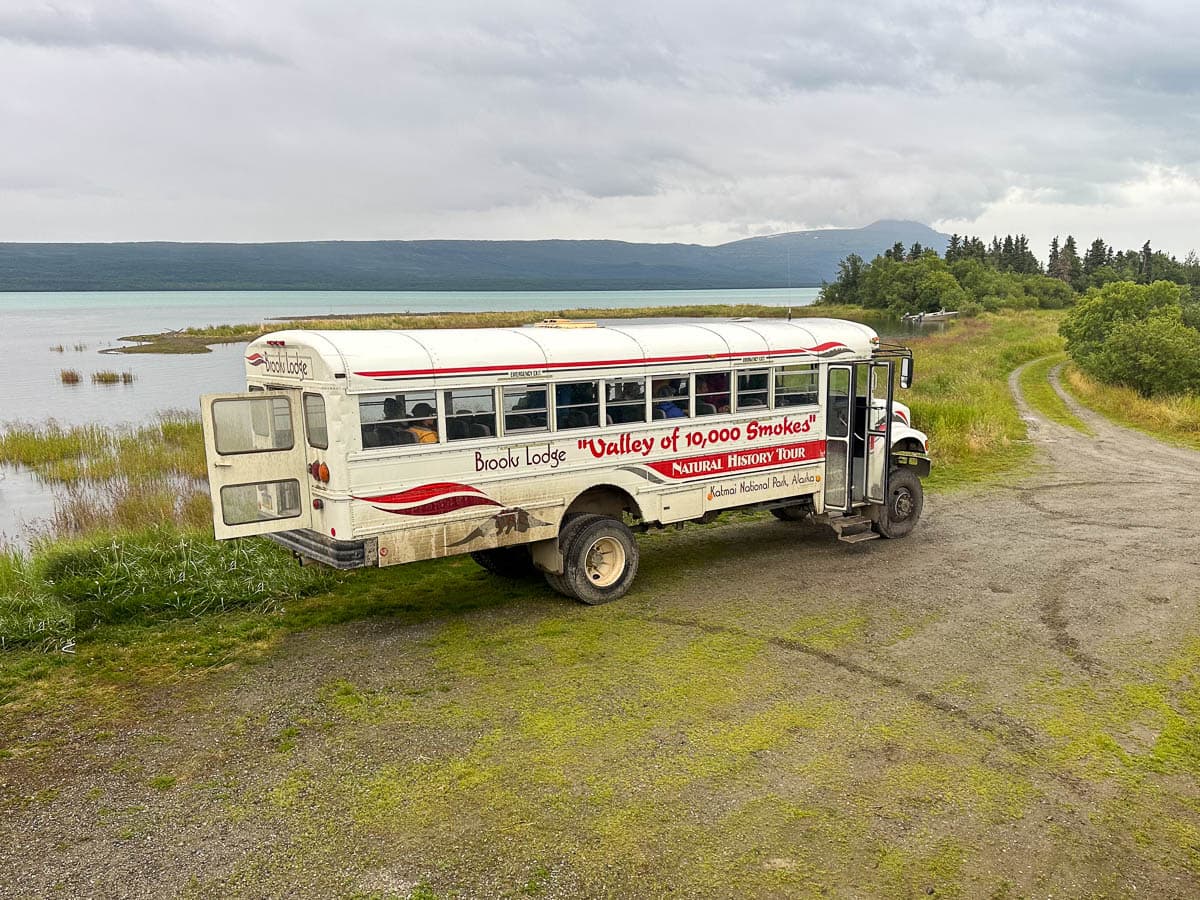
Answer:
[{"left": 202, "top": 318, "right": 930, "bottom": 604}]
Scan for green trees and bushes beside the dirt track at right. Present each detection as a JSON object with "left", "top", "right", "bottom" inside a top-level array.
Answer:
[{"left": 818, "top": 234, "right": 1200, "bottom": 396}]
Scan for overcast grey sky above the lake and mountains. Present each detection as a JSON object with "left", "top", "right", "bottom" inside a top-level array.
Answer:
[{"left": 0, "top": 0, "right": 1200, "bottom": 258}]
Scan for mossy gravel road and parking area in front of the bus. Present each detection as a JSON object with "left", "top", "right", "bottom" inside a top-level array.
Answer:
[{"left": 0, "top": 362, "right": 1200, "bottom": 898}]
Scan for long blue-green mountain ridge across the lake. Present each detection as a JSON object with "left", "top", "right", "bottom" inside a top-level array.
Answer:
[{"left": 0, "top": 220, "right": 949, "bottom": 292}]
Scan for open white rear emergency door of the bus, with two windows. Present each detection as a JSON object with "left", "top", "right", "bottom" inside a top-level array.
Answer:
[{"left": 200, "top": 390, "right": 312, "bottom": 539}]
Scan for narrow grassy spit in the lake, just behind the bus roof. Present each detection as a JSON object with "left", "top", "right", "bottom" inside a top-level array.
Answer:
[{"left": 119, "top": 304, "right": 894, "bottom": 353}]
